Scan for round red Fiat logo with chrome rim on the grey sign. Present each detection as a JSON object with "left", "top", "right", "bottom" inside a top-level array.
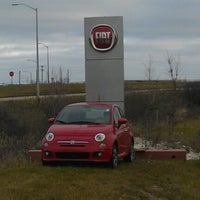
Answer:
[{"left": 90, "top": 24, "right": 117, "bottom": 51}]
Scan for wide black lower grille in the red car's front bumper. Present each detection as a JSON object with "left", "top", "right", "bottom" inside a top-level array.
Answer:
[{"left": 56, "top": 152, "right": 89, "bottom": 160}]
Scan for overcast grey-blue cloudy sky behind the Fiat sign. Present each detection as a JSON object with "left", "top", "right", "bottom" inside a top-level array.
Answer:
[{"left": 0, "top": 0, "right": 200, "bottom": 84}]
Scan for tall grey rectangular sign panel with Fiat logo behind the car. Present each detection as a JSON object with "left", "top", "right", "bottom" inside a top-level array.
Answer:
[{"left": 84, "top": 17, "right": 124, "bottom": 111}]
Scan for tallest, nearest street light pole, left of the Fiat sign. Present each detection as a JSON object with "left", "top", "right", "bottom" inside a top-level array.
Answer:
[{"left": 12, "top": 3, "right": 40, "bottom": 102}]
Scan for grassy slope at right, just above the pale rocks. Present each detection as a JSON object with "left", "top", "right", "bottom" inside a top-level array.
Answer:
[{"left": 134, "top": 118, "right": 200, "bottom": 152}]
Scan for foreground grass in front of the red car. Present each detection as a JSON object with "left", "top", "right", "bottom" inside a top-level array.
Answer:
[{"left": 0, "top": 160, "right": 200, "bottom": 200}]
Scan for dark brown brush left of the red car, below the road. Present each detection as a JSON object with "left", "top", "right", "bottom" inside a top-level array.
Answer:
[{"left": 0, "top": 96, "right": 84, "bottom": 163}]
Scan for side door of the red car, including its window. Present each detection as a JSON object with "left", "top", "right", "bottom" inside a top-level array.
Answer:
[{"left": 114, "top": 106, "right": 129, "bottom": 154}]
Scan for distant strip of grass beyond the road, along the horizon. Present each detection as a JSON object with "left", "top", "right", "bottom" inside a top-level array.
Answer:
[{"left": 0, "top": 81, "right": 185, "bottom": 98}]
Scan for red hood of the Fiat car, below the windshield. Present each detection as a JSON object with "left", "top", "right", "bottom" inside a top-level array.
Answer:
[{"left": 48, "top": 124, "right": 112, "bottom": 136}]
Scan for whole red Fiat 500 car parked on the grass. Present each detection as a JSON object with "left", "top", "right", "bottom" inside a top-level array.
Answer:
[{"left": 41, "top": 103, "right": 134, "bottom": 168}]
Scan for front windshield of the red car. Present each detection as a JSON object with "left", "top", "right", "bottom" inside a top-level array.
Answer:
[{"left": 56, "top": 105, "right": 110, "bottom": 124}]
